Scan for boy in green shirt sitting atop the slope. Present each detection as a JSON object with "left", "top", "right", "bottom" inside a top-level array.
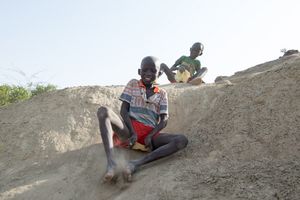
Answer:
[{"left": 160, "top": 42, "right": 207, "bottom": 83}]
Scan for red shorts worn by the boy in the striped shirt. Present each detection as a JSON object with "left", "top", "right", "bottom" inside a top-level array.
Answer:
[{"left": 113, "top": 119, "right": 159, "bottom": 147}]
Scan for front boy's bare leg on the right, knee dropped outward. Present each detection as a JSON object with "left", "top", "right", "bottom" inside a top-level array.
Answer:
[{"left": 126, "top": 133, "right": 188, "bottom": 179}]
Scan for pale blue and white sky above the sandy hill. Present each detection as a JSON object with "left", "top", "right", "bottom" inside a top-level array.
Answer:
[{"left": 0, "top": 0, "right": 300, "bottom": 88}]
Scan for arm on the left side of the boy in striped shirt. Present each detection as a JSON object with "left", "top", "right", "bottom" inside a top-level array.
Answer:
[{"left": 120, "top": 101, "right": 137, "bottom": 147}]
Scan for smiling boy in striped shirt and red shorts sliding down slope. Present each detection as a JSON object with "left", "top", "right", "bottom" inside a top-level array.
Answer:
[{"left": 97, "top": 56, "right": 188, "bottom": 181}]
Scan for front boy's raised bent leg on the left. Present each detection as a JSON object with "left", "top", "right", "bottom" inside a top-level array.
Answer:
[{"left": 97, "top": 106, "right": 129, "bottom": 181}]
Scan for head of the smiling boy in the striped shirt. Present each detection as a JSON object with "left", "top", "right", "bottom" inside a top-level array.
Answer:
[{"left": 139, "top": 56, "right": 160, "bottom": 85}]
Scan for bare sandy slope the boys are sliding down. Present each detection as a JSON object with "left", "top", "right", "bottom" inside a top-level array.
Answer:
[{"left": 0, "top": 54, "right": 300, "bottom": 200}]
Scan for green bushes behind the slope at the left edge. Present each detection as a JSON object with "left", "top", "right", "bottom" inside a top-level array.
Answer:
[{"left": 0, "top": 84, "right": 57, "bottom": 106}]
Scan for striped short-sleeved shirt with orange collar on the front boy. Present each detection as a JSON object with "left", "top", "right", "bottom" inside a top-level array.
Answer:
[{"left": 119, "top": 79, "right": 168, "bottom": 127}]
